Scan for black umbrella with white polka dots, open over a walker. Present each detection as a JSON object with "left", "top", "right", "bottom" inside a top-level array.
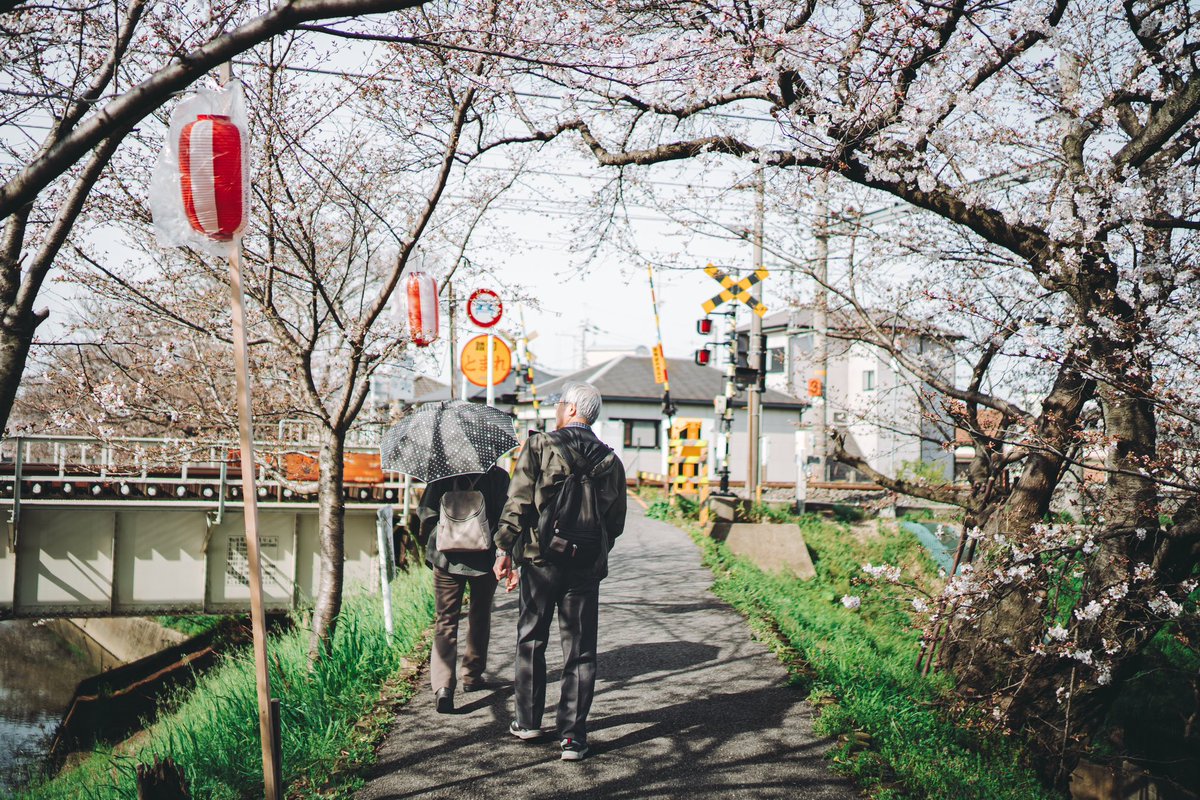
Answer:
[{"left": 379, "top": 401, "right": 517, "bottom": 482}]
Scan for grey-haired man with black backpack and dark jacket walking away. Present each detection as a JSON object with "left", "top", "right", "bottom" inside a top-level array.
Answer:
[{"left": 496, "top": 384, "right": 625, "bottom": 762}]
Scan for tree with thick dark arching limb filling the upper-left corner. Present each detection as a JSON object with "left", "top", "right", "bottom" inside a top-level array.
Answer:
[{"left": 0, "top": 0, "right": 434, "bottom": 438}]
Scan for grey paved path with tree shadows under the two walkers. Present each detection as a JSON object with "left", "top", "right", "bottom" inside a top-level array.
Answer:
[{"left": 358, "top": 503, "right": 858, "bottom": 800}]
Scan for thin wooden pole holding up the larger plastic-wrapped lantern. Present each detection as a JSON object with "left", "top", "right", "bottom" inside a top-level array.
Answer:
[{"left": 229, "top": 245, "right": 283, "bottom": 800}]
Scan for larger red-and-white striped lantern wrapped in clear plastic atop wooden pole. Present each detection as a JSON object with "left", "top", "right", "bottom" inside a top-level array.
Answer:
[{"left": 179, "top": 114, "right": 246, "bottom": 241}]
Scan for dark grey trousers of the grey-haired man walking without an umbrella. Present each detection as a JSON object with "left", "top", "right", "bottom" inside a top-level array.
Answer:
[{"left": 516, "top": 565, "right": 600, "bottom": 741}]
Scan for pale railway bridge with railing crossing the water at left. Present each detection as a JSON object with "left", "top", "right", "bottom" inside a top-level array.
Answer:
[{"left": 0, "top": 437, "right": 409, "bottom": 619}]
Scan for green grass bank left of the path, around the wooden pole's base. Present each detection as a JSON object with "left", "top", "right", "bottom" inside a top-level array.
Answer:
[{"left": 14, "top": 570, "right": 433, "bottom": 800}]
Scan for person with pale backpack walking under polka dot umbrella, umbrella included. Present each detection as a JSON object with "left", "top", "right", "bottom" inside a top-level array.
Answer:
[{"left": 382, "top": 401, "right": 517, "bottom": 714}]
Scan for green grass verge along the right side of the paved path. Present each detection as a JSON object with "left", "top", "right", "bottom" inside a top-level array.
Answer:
[{"left": 652, "top": 506, "right": 1058, "bottom": 800}]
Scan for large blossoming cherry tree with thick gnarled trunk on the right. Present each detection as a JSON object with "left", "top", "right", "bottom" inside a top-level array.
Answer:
[{"left": 362, "top": 0, "right": 1200, "bottom": 778}]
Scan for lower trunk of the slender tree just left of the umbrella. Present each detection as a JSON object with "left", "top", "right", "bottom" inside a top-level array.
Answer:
[{"left": 308, "top": 429, "right": 346, "bottom": 661}]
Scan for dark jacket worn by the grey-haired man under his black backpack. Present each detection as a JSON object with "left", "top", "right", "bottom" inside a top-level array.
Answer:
[{"left": 496, "top": 427, "right": 626, "bottom": 578}]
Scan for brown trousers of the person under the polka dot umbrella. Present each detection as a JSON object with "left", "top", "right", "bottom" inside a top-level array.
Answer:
[{"left": 430, "top": 567, "right": 496, "bottom": 692}]
